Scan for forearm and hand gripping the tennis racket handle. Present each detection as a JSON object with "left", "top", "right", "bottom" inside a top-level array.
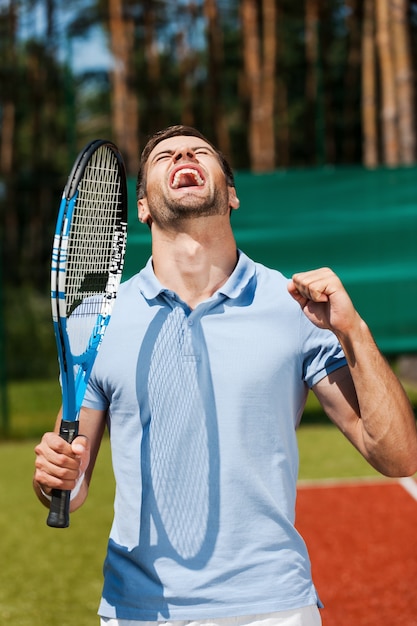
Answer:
[{"left": 33, "top": 408, "right": 106, "bottom": 511}]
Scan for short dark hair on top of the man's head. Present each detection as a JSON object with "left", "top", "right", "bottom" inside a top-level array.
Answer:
[{"left": 136, "top": 124, "right": 235, "bottom": 200}]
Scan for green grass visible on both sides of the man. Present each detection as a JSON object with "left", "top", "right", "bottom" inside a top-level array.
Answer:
[{"left": 0, "top": 372, "right": 417, "bottom": 626}]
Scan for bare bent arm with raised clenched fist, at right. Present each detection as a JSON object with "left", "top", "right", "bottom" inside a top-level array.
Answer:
[{"left": 288, "top": 268, "right": 417, "bottom": 476}]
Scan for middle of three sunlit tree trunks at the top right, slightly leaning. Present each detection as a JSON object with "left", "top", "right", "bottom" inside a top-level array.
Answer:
[{"left": 375, "top": 0, "right": 399, "bottom": 167}]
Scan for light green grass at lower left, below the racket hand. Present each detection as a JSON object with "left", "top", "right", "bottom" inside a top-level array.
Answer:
[{"left": 0, "top": 440, "right": 113, "bottom": 626}]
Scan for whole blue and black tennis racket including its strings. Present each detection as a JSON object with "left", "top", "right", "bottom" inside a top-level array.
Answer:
[{"left": 47, "top": 139, "right": 127, "bottom": 528}]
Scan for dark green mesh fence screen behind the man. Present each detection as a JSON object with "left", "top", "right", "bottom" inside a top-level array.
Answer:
[{"left": 124, "top": 167, "right": 417, "bottom": 354}]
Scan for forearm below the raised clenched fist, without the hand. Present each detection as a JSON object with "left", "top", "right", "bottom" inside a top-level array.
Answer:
[{"left": 338, "top": 315, "right": 417, "bottom": 476}]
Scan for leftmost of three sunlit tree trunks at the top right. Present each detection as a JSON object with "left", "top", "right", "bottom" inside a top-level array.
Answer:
[{"left": 362, "top": 0, "right": 378, "bottom": 168}]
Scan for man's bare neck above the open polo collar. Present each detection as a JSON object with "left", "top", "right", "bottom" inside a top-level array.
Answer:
[{"left": 152, "top": 218, "right": 237, "bottom": 309}]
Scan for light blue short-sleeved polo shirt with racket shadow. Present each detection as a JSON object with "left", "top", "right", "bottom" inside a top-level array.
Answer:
[{"left": 85, "top": 252, "right": 346, "bottom": 620}]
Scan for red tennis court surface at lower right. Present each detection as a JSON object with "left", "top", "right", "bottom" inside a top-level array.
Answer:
[{"left": 296, "top": 478, "right": 417, "bottom": 626}]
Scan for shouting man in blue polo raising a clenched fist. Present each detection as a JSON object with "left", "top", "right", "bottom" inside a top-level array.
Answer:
[{"left": 34, "top": 126, "right": 417, "bottom": 626}]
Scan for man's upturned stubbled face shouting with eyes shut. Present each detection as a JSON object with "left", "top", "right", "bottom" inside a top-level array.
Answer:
[{"left": 139, "top": 136, "right": 236, "bottom": 226}]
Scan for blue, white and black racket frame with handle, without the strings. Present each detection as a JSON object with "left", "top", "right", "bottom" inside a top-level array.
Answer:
[{"left": 47, "top": 139, "right": 128, "bottom": 528}]
